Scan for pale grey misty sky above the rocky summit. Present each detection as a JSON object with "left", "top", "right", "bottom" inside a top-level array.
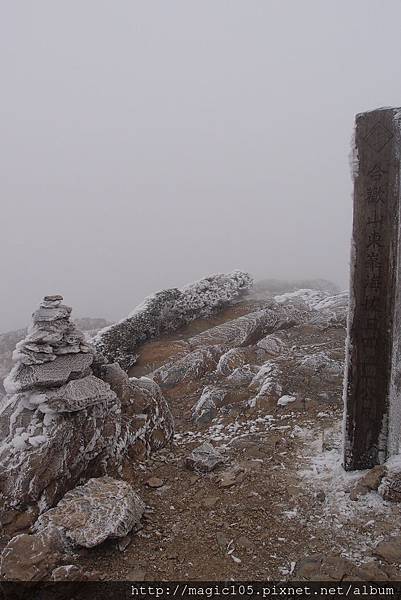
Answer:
[{"left": 0, "top": 0, "right": 401, "bottom": 331}]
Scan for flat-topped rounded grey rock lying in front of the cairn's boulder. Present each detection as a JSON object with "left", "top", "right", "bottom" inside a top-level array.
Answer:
[{"left": 35, "top": 477, "right": 145, "bottom": 548}]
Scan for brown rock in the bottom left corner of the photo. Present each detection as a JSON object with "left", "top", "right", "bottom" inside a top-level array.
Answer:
[{"left": 0, "top": 527, "right": 64, "bottom": 581}]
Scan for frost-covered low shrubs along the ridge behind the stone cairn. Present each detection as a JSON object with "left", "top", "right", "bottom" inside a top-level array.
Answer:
[{"left": 94, "top": 271, "right": 252, "bottom": 370}]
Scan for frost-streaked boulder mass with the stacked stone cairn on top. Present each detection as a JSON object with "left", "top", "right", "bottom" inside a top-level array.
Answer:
[{"left": 0, "top": 296, "right": 173, "bottom": 523}]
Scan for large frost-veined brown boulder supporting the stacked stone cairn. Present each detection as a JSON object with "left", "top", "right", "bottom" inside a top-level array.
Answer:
[{"left": 0, "top": 397, "right": 122, "bottom": 510}]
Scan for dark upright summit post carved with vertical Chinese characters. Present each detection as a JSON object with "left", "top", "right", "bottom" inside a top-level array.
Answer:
[{"left": 344, "top": 108, "right": 401, "bottom": 471}]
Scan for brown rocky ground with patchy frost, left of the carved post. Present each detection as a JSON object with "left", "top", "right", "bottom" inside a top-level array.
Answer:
[{"left": 76, "top": 292, "right": 401, "bottom": 580}]
